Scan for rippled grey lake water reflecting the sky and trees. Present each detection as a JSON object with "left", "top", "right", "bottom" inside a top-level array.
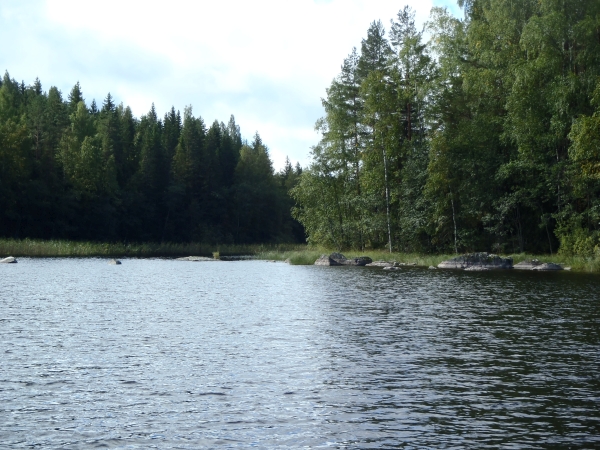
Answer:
[{"left": 0, "top": 258, "right": 600, "bottom": 449}]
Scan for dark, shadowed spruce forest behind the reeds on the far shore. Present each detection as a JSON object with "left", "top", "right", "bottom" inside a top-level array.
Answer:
[{"left": 0, "top": 73, "right": 304, "bottom": 244}]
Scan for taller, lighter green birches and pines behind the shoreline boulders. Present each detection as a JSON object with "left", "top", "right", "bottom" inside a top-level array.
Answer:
[{"left": 292, "top": 0, "right": 600, "bottom": 255}]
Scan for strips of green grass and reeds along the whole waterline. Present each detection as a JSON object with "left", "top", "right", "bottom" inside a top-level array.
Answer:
[{"left": 0, "top": 239, "right": 600, "bottom": 273}]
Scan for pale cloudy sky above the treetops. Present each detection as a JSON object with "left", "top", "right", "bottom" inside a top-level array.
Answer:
[{"left": 0, "top": 0, "right": 460, "bottom": 170}]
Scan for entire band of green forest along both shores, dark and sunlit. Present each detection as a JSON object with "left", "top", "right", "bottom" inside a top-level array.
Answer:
[{"left": 0, "top": 0, "right": 600, "bottom": 256}]
